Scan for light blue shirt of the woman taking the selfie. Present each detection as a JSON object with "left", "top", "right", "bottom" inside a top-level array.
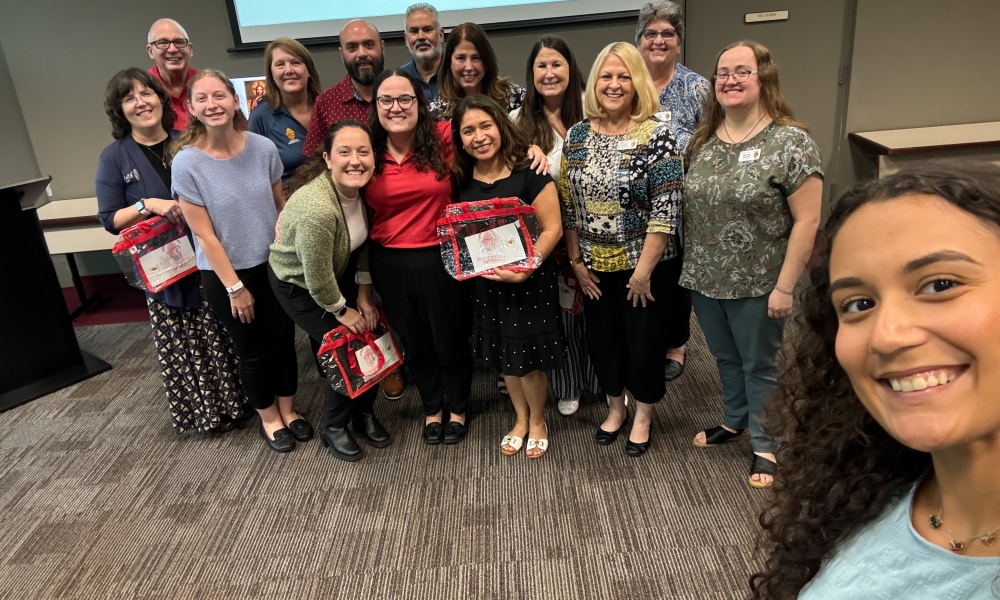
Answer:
[{"left": 799, "top": 486, "right": 1000, "bottom": 600}]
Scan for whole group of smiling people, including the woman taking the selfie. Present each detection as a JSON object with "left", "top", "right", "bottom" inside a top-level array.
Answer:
[{"left": 97, "top": 5, "right": 1000, "bottom": 598}]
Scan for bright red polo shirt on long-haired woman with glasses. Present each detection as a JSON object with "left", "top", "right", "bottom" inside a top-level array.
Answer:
[{"left": 365, "top": 121, "right": 454, "bottom": 248}]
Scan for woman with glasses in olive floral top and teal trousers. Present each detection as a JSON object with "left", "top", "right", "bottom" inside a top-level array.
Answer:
[{"left": 680, "top": 41, "right": 823, "bottom": 487}]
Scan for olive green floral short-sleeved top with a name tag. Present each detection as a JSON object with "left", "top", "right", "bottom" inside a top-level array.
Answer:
[{"left": 680, "top": 123, "right": 823, "bottom": 300}]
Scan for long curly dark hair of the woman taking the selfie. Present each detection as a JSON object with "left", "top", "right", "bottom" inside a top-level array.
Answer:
[{"left": 750, "top": 161, "right": 1000, "bottom": 600}]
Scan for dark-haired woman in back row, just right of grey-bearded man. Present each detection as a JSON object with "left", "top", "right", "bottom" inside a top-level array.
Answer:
[{"left": 430, "top": 23, "right": 524, "bottom": 120}]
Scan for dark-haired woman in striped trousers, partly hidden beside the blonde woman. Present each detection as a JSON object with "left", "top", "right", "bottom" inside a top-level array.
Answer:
[{"left": 510, "top": 35, "right": 600, "bottom": 415}]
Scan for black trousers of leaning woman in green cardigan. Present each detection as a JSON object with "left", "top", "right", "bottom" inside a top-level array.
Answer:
[{"left": 267, "top": 250, "right": 378, "bottom": 427}]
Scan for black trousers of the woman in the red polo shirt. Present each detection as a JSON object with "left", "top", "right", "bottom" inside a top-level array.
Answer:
[{"left": 368, "top": 242, "right": 472, "bottom": 415}]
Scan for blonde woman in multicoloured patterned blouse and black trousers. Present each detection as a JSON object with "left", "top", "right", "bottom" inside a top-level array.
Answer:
[{"left": 559, "top": 42, "right": 684, "bottom": 456}]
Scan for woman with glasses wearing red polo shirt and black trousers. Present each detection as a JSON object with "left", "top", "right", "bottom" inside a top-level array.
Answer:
[{"left": 365, "top": 69, "right": 472, "bottom": 444}]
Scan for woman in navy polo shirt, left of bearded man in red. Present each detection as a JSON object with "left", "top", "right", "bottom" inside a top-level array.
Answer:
[{"left": 247, "top": 38, "right": 323, "bottom": 184}]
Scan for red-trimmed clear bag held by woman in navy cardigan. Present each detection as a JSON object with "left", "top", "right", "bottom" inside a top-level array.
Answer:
[{"left": 111, "top": 216, "right": 198, "bottom": 293}]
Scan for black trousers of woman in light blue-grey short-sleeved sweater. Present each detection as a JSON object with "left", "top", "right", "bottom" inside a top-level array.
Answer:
[{"left": 201, "top": 263, "right": 299, "bottom": 410}]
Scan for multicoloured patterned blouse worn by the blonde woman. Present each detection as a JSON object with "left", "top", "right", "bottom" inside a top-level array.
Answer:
[{"left": 559, "top": 117, "right": 684, "bottom": 273}]
